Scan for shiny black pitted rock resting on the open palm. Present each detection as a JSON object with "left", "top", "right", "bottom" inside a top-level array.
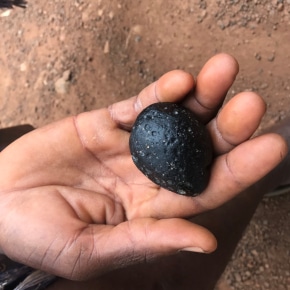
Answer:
[{"left": 130, "top": 103, "right": 212, "bottom": 196}]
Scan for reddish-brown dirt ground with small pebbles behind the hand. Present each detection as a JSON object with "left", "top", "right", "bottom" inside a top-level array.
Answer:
[{"left": 0, "top": 0, "right": 290, "bottom": 290}]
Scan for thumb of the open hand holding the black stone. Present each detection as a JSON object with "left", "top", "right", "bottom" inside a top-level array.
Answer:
[{"left": 73, "top": 218, "right": 216, "bottom": 279}]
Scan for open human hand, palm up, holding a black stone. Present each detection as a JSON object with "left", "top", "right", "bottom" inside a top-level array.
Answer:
[{"left": 0, "top": 54, "right": 287, "bottom": 279}]
